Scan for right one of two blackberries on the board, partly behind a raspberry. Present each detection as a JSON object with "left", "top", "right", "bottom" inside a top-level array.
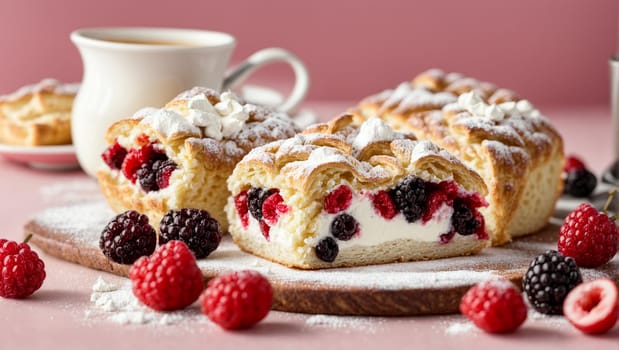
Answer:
[{"left": 159, "top": 208, "right": 221, "bottom": 259}]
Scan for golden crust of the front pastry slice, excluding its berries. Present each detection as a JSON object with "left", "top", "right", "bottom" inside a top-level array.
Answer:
[{"left": 226, "top": 114, "right": 489, "bottom": 269}]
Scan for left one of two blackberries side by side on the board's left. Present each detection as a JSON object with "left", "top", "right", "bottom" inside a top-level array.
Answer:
[{"left": 99, "top": 210, "right": 157, "bottom": 264}]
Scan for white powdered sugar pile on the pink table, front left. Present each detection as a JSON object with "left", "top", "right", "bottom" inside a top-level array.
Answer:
[{"left": 84, "top": 276, "right": 213, "bottom": 326}]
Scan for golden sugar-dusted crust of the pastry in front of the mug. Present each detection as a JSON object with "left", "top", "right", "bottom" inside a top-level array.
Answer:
[{"left": 97, "top": 88, "right": 296, "bottom": 231}]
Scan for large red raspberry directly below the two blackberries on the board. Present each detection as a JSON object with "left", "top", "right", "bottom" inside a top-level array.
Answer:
[{"left": 129, "top": 241, "right": 204, "bottom": 311}]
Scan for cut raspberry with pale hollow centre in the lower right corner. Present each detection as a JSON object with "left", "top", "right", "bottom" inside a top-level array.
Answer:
[{"left": 563, "top": 278, "right": 619, "bottom": 334}]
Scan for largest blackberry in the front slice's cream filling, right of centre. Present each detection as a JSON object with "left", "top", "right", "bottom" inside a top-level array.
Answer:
[{"left": 389, "top": 176, "right": 427, "bottom": 222}]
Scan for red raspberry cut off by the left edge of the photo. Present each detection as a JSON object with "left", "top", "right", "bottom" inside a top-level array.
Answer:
[{"left": 0, "top": 239, "right": 45, "bottom": 299}]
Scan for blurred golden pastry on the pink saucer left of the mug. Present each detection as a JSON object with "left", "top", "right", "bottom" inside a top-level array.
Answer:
[{"left": 0, "top": 79, "right": 79, "bottom": 146}]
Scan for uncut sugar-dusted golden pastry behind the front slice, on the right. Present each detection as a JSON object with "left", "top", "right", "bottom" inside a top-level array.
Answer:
[{"left": 352, "top": 69, "right": 563, "bottom": 245}]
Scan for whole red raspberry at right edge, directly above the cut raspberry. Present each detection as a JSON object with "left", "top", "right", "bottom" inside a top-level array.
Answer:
[{"left": 558, "top": 203, "right": 619, "bottom": 268}]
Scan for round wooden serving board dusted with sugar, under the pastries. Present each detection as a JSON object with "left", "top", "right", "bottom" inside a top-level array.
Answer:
[{"left": 25, "top": 201, "right": 619, "bottom": 316}]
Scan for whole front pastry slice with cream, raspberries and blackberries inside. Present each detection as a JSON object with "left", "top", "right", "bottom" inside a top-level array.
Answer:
[{"left": 226, "top": 115, "right": 489, "bottom": 269}]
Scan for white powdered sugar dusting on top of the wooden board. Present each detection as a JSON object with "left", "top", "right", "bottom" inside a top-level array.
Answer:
[{"left": 34, "top": 201, "right": 619, "bottom": 290}]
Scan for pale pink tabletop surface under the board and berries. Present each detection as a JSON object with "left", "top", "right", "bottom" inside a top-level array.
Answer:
[{"left": 0, "top": 103, "right": 619, "bottom": 350}]
